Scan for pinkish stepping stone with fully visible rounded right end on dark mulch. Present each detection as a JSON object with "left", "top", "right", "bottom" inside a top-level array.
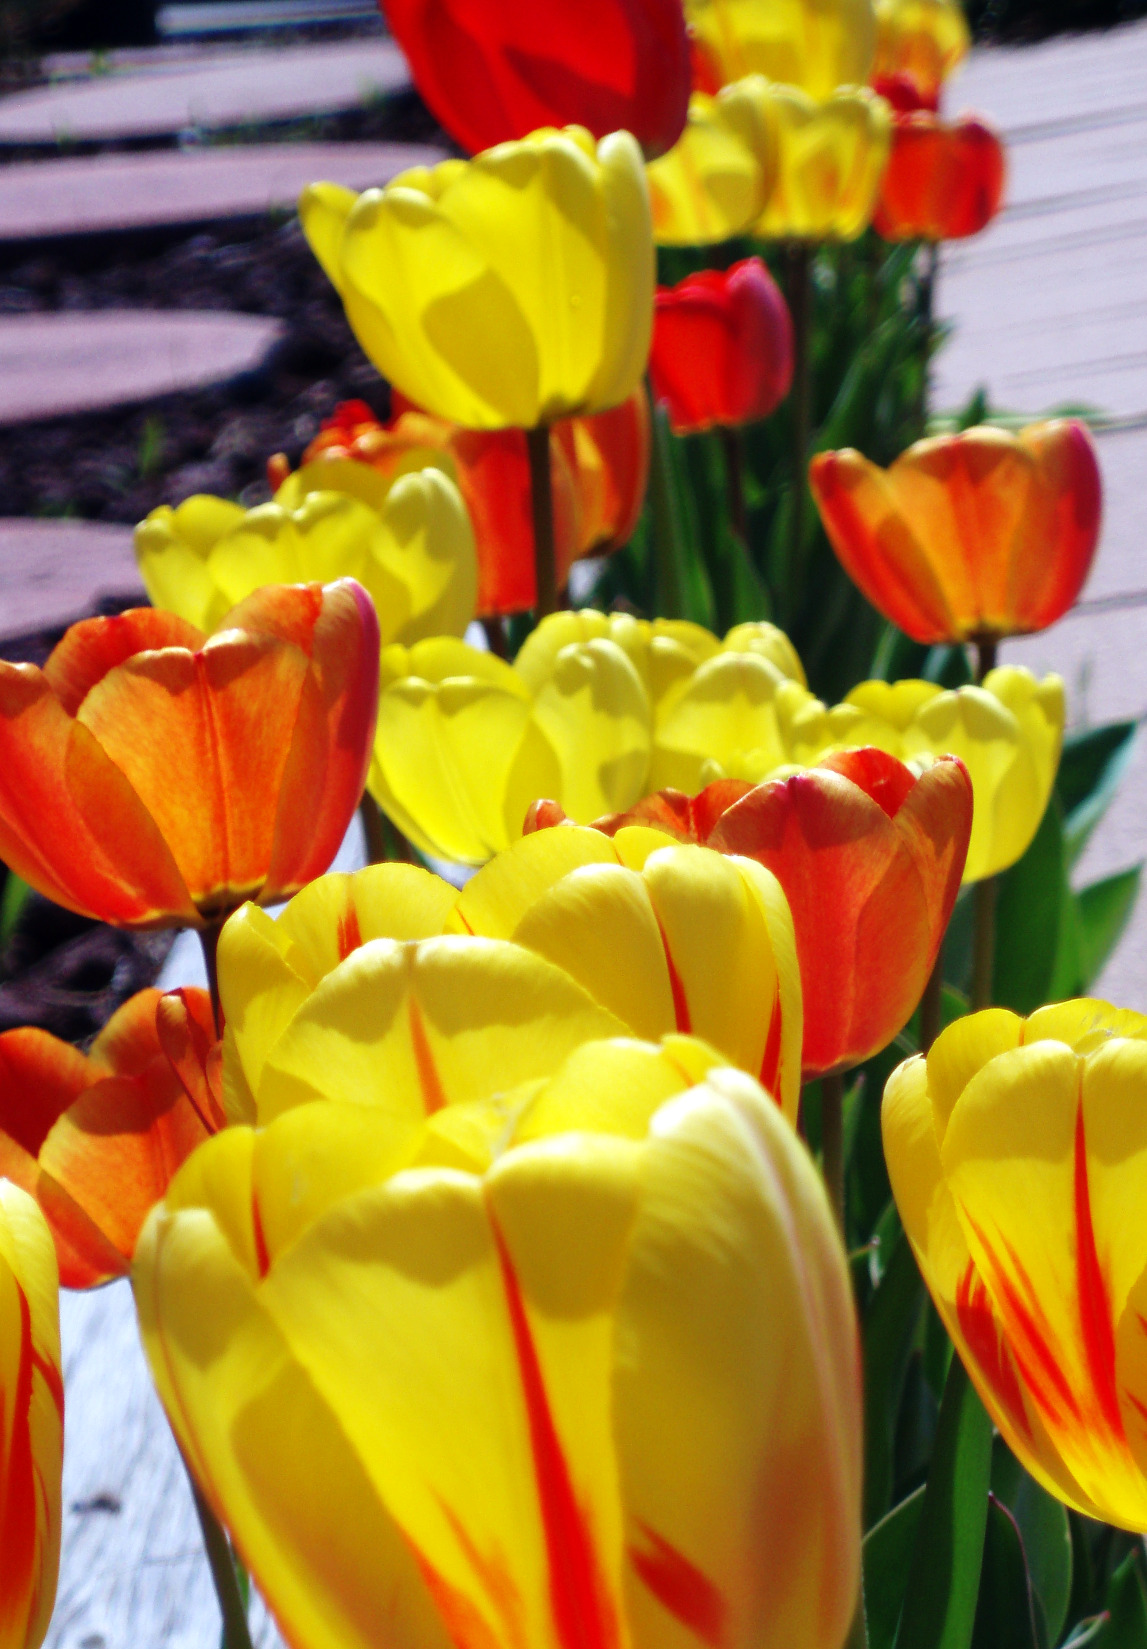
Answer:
[{"left": 0, "top": 310, "right": 283, "bottom": 427}]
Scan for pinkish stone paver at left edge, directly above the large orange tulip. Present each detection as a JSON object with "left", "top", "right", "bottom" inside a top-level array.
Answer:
[{"left": 0, "top": 519, "right": 147, "bottom": 641}]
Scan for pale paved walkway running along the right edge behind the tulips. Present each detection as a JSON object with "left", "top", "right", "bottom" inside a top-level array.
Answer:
[{"left": 936, "top": 23, "right": 1147, "bottom": 1011}]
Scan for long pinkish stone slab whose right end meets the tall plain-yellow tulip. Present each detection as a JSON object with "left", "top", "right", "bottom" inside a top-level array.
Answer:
[{"left": 0, "top": 143, "right": 445, "bottom": 242}]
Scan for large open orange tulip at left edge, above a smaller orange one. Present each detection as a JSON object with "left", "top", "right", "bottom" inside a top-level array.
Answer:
[{"left": 0, "top": 579, "right": 379, "bottom": 928}]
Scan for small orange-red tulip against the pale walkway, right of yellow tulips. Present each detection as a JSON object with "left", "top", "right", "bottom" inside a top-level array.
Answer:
[{"left": 873, "top": 112, "right": 1007, "bottom": 241}]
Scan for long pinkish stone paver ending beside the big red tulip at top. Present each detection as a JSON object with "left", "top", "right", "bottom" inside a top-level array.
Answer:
[{"left": 0, "top": 40, "right": 409, "bottom": 145}]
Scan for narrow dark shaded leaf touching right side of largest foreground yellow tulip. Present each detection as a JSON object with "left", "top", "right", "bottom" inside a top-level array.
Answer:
[{"left": 864, "top": 1230, "right": 925, "bottom": 1529}]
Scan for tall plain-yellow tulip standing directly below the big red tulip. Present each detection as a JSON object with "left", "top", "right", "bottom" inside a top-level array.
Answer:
[{"left": 298, "top": 127, "right": 654, "bottom": 429}]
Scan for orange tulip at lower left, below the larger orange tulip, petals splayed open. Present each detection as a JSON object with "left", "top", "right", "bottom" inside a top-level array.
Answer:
[{"left": 0, "top": 989, "right": 222, "bottom": 1288}]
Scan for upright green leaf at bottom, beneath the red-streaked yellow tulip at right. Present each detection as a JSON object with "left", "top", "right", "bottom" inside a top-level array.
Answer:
[{"left": 895, "top": 1357, "right": 992, "bottom": 1649}]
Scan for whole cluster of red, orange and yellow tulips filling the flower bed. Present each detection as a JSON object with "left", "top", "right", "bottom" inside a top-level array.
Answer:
[{"left": 0, "top": 0, "right": 1147, "bottom": 1649}]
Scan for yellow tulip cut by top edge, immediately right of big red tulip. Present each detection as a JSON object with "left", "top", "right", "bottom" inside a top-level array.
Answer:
[{"left": 686, "top": 0, "right": 877, "bottom": 99}]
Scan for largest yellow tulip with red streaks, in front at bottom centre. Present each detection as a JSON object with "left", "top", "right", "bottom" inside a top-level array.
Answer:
[{"left": 133, "top": 1029, "right": 862, "bottom": 1649}]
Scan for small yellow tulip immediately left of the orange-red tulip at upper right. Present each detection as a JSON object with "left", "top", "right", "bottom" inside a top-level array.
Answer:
[{"left": 753, "top": 86, "right": 892, "bottom": 241}]
